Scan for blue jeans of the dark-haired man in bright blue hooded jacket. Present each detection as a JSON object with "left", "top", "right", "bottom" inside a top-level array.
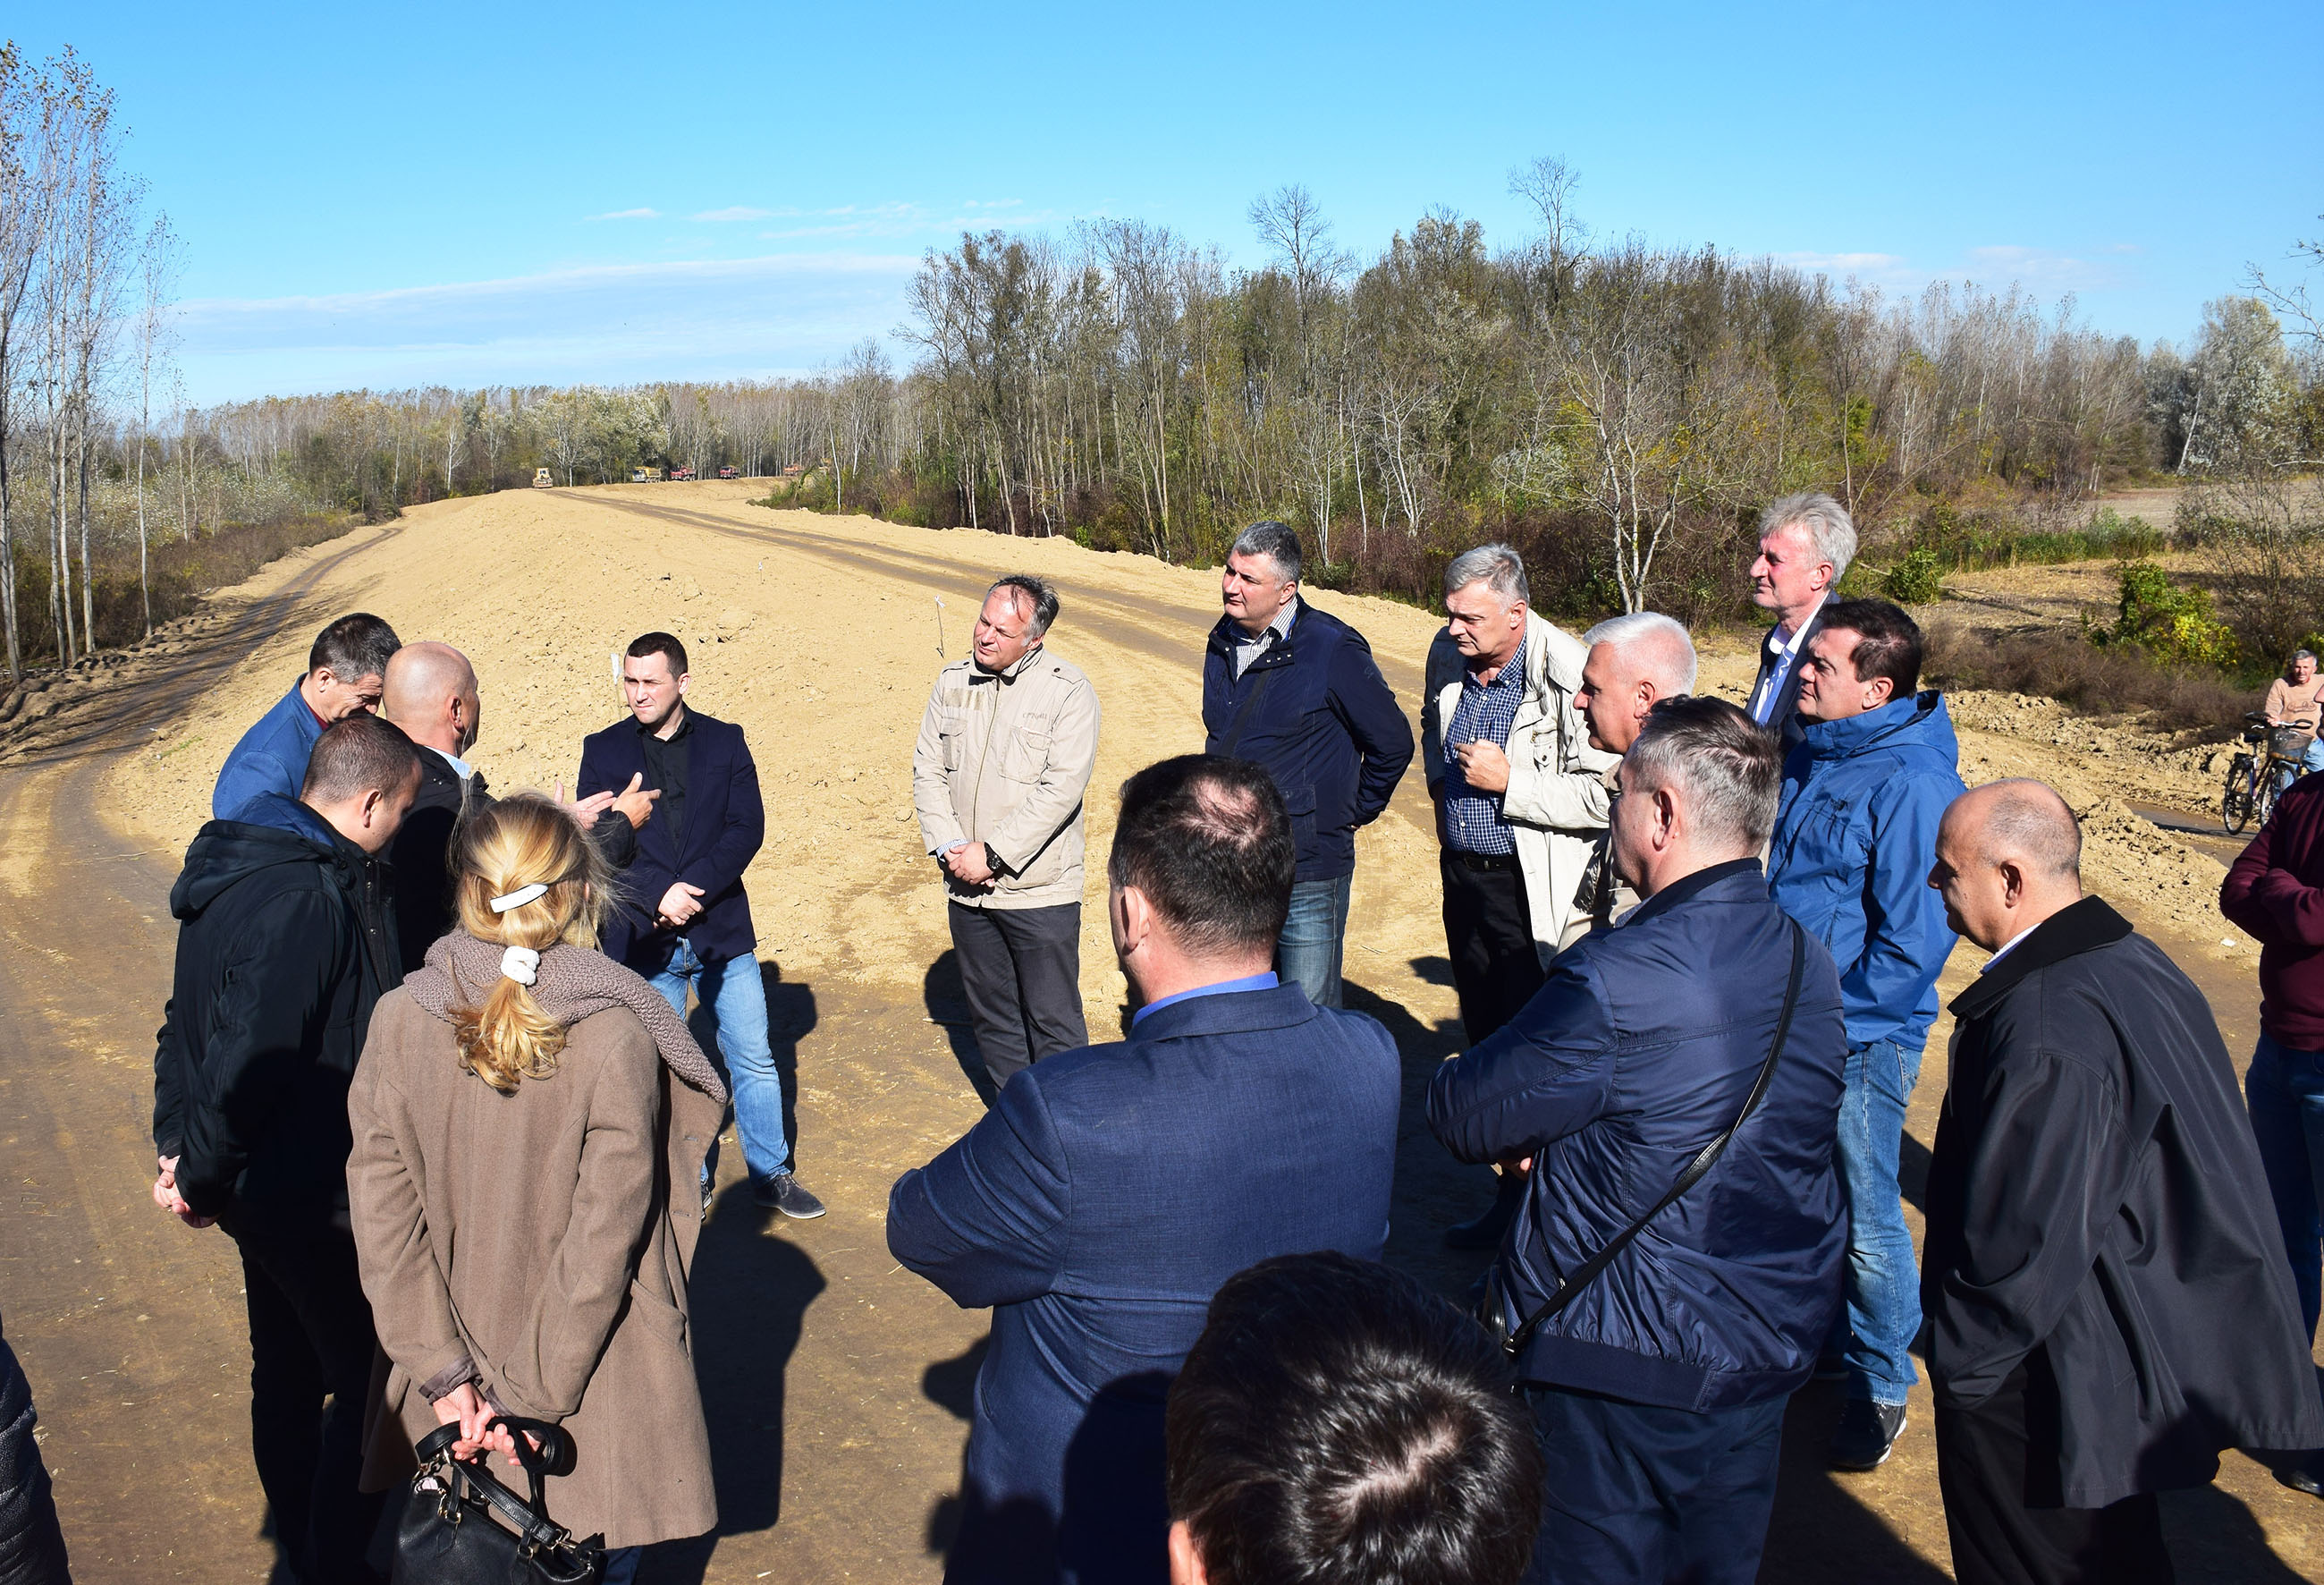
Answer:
[{"left": 1834, "top": 1041, "right": 1922, "bottom": 1403}]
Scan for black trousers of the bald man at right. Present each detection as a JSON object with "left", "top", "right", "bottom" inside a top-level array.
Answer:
[{"left": 1936, "top": 1351, "right": 2177, "bottom": 1585}]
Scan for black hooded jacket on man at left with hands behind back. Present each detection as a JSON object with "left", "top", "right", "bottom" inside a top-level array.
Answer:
[{"left": 154, "top": 792, "right": 404, "bottom": 1234}]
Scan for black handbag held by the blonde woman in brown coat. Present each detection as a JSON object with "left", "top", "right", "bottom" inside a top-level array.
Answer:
[{"left": 388, "top": 1415, "right": 604, "bottom": 1585}]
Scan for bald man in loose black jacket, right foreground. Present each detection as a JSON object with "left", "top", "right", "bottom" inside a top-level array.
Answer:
[{"left": 1922, "top": 781, "right": 2324, "bottom": 1585}]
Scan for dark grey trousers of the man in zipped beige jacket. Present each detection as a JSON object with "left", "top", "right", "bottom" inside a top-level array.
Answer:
[{"left": 946, "top": 902, "right": 1090, "bottom": 1085}]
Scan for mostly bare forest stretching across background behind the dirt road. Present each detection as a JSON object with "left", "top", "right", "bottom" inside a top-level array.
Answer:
[{"left": 0, "top": 49, "right": 2324, "bottom": 676}]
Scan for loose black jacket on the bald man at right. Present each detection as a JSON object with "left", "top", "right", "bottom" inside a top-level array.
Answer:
[{"left": 1922, "top": 897, "right": 2324, "bottom": 1508}]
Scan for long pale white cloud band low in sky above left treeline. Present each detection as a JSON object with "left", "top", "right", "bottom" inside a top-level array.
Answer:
[{"left": 179, "top": 253, "right": 918, "bottom": 402}]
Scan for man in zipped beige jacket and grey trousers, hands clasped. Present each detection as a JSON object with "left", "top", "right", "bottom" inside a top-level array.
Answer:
[{"left": 911, "top": 574, "right": 1097, "bottom": 1085}]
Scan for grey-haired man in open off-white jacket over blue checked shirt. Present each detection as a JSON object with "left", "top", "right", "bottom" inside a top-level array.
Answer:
[{"left": 1420, "top": 544, "right": 1615, "bottom": 1248}]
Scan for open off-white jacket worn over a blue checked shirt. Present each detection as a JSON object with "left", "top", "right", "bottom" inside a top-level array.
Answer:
[{"left": 1420, "top": 611, "right": 1620, "bottom": 964}]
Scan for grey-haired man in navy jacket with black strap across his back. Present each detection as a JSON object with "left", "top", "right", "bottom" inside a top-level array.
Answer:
[{"left": 1427, "top": 697, "right": 1847, "bottom": 1585}]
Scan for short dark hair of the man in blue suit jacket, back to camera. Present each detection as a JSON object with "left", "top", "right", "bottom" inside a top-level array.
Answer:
[{"left": 1106, "top": 753, "right": 1299, "bottom": 957}]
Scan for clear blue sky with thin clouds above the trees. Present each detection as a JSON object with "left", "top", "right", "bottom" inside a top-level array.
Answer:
[{"left": 36, "top": 0, "right": 2324, "bottom": 402}]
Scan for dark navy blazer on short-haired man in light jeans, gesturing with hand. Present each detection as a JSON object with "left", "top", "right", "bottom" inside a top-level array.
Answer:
[{"left": 574, "top": 711, "right": 767, "bottom": 974}]
